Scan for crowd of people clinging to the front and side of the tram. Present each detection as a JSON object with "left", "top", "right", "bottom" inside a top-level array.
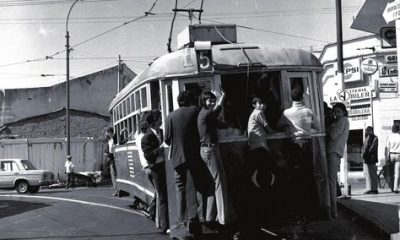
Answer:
[{"left": 102, "top": 88, "right": 349, "bottom": 239}]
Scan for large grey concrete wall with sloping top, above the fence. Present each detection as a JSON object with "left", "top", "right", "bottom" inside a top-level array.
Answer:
[{"left": 0, "top": 65, "right": 135, "bottom": 126}]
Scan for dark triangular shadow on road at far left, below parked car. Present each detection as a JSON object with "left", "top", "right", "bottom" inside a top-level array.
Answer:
[{"left": 0, "top": 200, "right": 50, "bottom": 218}]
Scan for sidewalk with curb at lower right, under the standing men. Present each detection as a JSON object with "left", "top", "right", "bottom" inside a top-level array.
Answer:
[{"left": 338, "top": 172, "right": 400, "bottom": 239}]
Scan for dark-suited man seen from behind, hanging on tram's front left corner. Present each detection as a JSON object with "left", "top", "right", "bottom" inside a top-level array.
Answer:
[{"left": 164, "top": 91, "right": 201, "bottom": 235}]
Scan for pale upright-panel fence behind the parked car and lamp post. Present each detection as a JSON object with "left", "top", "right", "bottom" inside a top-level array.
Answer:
[{"left": 0, "top": 138, "right": 105, "bottom": 180}]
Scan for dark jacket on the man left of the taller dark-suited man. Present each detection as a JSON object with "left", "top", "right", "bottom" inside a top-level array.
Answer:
[{"left": 141, "top": 128, "right": 160, "bottom": 168}]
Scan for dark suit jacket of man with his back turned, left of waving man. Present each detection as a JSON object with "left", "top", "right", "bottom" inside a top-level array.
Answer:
[{"left": 164, "top": 106, "right": 200, "bottom": 168}]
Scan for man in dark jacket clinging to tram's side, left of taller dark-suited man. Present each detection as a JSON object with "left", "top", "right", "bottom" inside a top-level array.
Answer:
[{"left": 139, "top": 117, "right": 169, "bottom": 233}]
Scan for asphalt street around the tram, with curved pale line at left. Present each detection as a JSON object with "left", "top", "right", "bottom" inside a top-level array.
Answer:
[{"left": 0, "top": 182, "right": 390, "bottom": 240}]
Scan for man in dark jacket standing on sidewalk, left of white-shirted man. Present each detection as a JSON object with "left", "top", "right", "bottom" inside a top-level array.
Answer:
[{"left": 361, "top": 126, "right": 378, "bottom": 194}]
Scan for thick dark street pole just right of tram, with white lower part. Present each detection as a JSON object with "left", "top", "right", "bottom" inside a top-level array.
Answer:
[{"left": 336, "top": 0, "right": 351, "bottom": 196}]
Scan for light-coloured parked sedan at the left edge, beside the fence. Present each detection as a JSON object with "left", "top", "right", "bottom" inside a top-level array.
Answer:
[{"left": 0, "top": 159, "right": 54, "bottom": 193}]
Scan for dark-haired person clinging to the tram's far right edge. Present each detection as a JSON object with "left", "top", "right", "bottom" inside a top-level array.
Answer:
[{"left": 327, "top": 103, "right": 350, "bottom": 218}]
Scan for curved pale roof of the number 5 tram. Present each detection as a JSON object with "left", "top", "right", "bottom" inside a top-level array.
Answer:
[{"left": 110, "top": 44, "right": 322, "bottom": 110}]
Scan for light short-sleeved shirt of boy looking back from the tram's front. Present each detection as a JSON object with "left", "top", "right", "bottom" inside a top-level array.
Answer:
[{"left": 247, "top": 109, "right": 269, "bottom": 150}]
